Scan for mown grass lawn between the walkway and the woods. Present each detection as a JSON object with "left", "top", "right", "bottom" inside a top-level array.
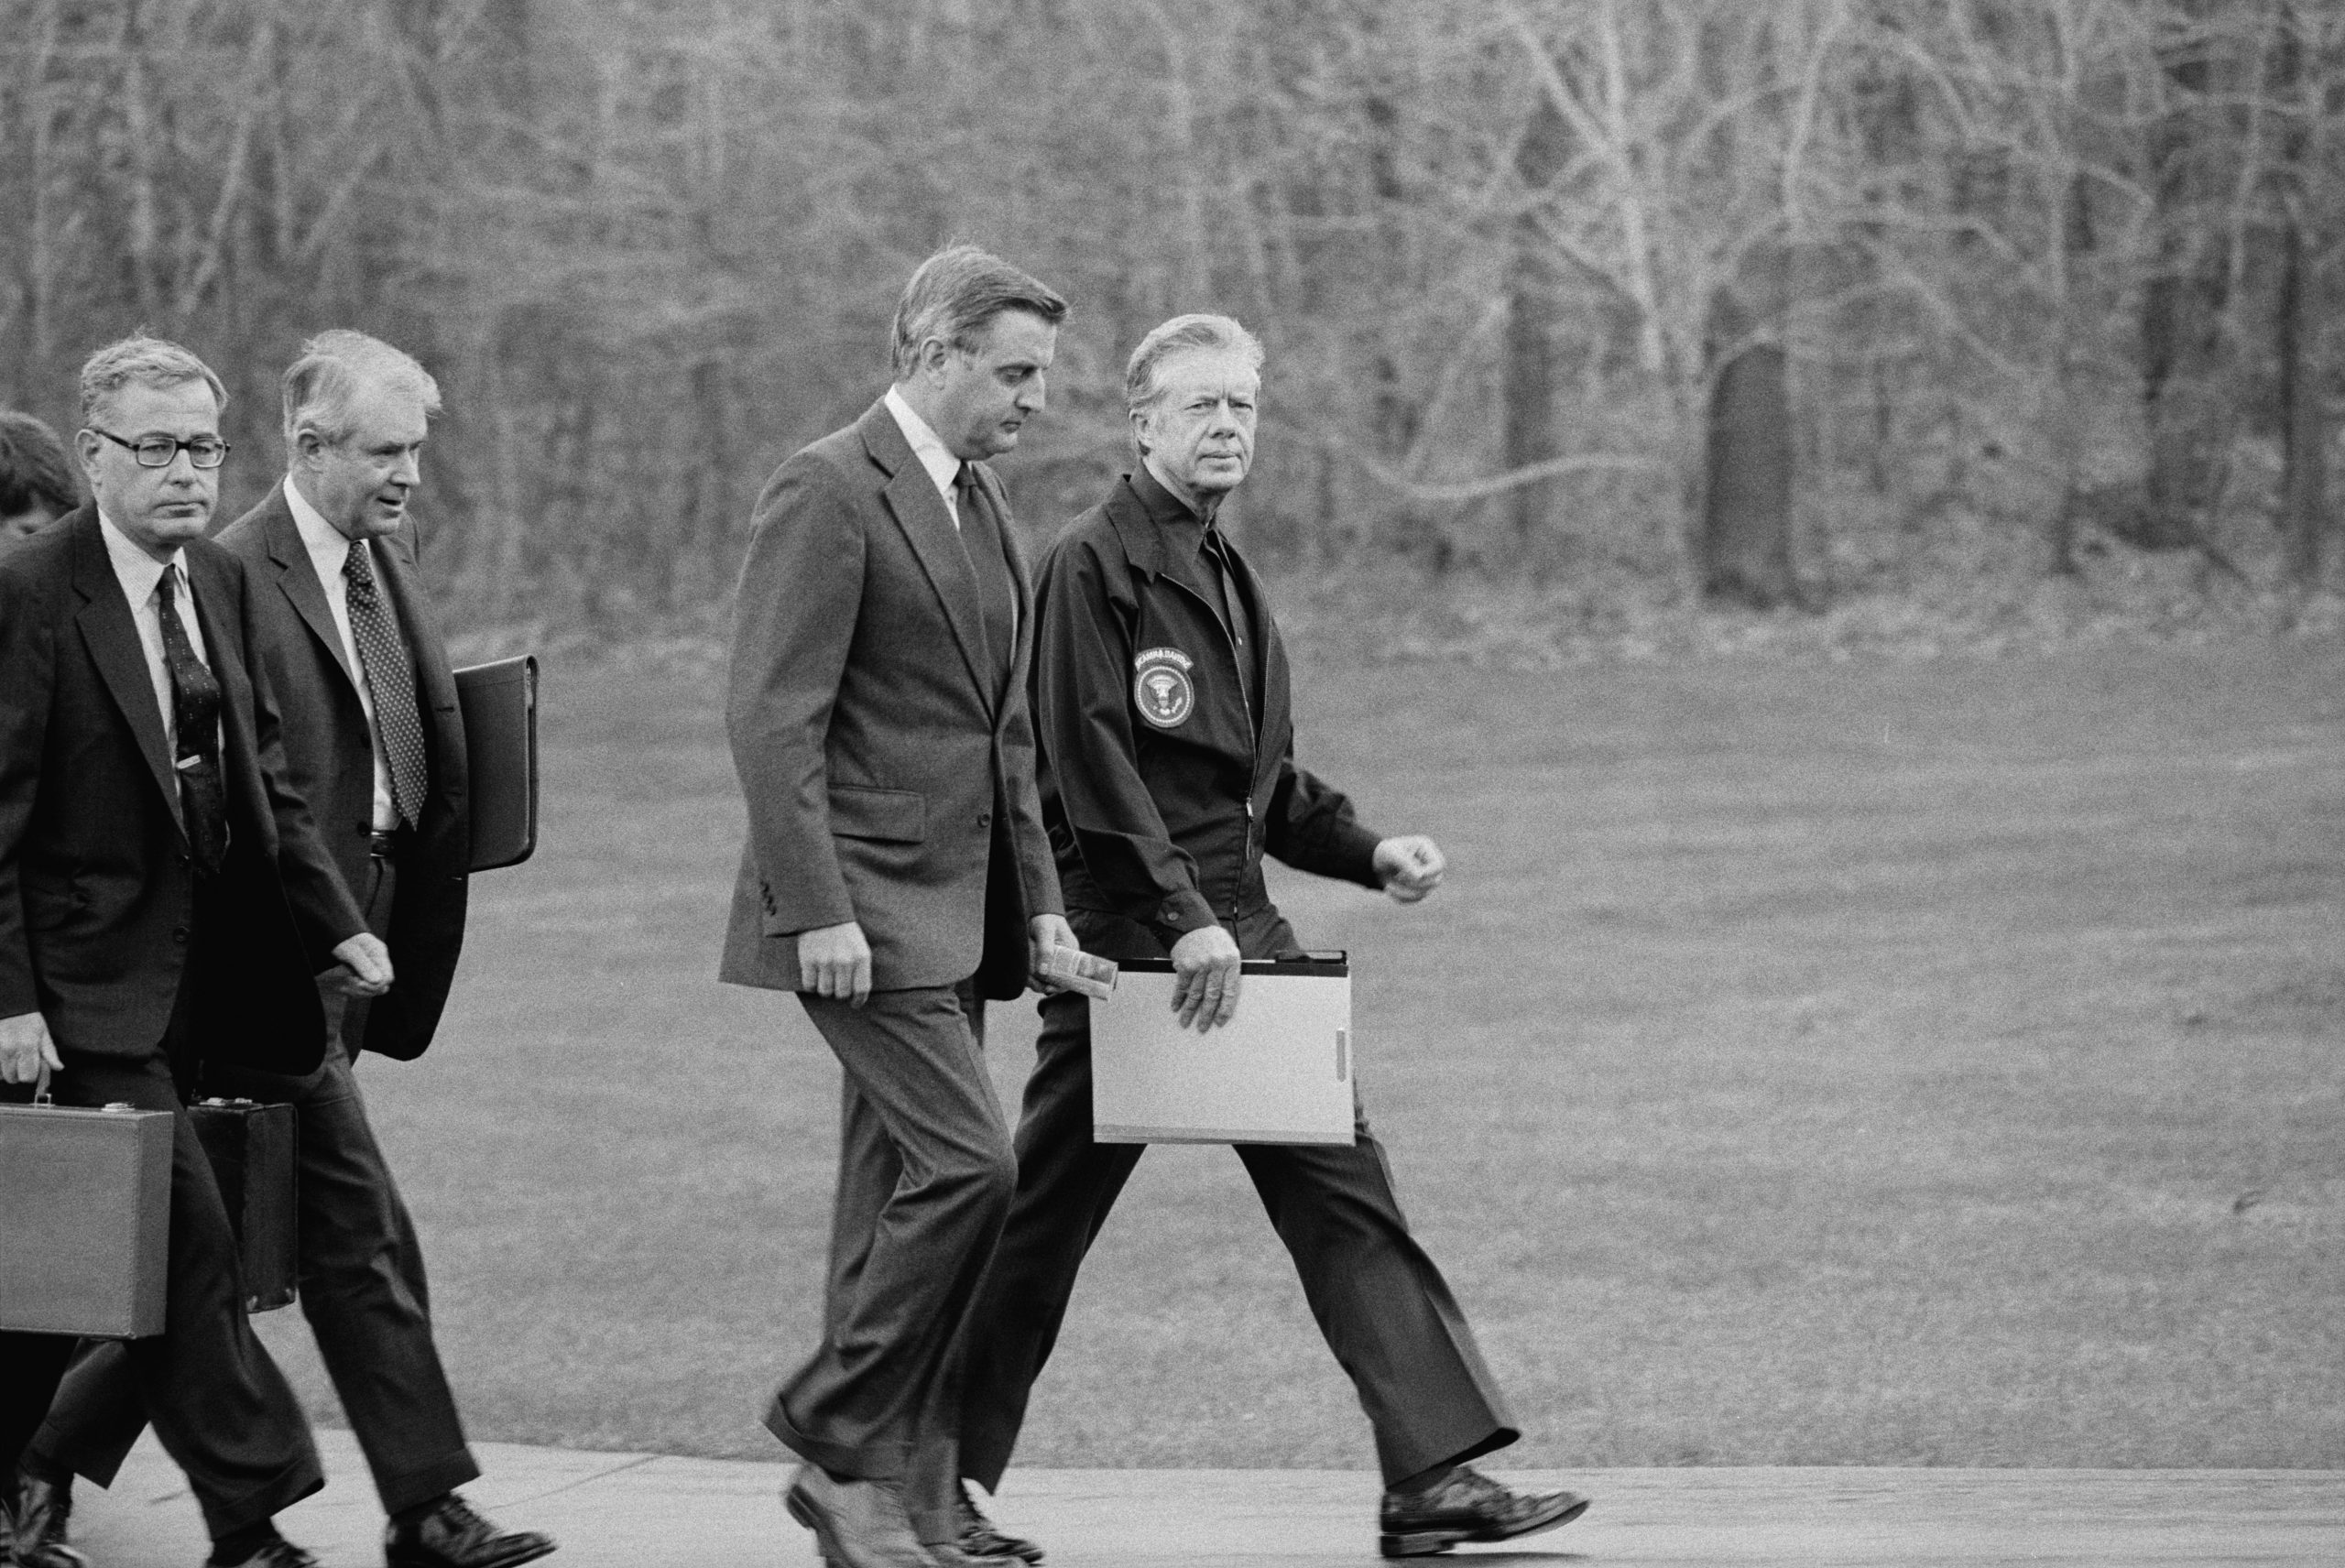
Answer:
[{"left": 263, "top": 642, "right": 2345, "bottom": 1467}]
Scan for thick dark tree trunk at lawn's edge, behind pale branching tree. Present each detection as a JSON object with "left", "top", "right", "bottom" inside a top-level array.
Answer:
[{"left": 1700, "top": 289, "right": 1801, "bottom": 609}]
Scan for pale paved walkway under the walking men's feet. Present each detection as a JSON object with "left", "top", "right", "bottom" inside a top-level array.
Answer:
[{"left": 75, "top": 1432, "right": 2345, "bottom": 1568}]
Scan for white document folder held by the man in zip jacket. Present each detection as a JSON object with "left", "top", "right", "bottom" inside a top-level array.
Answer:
[{"left": 1090, "top": 956, "right": 1353, "bottom": 1144}]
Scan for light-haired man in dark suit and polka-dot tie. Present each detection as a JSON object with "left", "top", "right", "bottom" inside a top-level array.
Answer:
[{"left": 24, "top": 331, "right": 553, "bottom": 1568}]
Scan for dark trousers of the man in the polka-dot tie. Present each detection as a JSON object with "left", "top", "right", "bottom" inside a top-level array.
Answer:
[{"left": 33, "top": 860, "right": 481, "bottom": 1514}]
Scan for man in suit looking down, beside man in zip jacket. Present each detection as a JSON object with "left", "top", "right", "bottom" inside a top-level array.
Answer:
[{"left": 720, "top": 246, "right": 1074, "bottom": 1568}]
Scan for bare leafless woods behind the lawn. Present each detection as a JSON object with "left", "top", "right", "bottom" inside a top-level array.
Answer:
[{"left": 0, "top": 0, "right": 2345, "bottom": 630}]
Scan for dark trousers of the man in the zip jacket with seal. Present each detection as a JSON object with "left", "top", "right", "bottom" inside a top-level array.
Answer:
[{"left": 962, "top": 909, "right": 1520, "bottom": 1491}]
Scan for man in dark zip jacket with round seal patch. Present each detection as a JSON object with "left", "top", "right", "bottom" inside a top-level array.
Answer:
[{"left": 962, "top": 316, "right": 1587, "bottom": 1561}]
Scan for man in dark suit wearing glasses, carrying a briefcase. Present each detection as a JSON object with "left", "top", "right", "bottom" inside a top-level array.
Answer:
[{"left": 0, "top": 338, "right": 392, "bottom": 1568}]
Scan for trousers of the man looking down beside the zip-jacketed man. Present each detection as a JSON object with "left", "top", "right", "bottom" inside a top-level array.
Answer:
[{"left": 765, "top": 986, "right": 1018, "bottom": 1542}]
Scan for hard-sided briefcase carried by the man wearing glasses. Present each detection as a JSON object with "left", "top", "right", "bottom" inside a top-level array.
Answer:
[{"left": 0, "top": 1097, "right": 171, "bottom": 1331}]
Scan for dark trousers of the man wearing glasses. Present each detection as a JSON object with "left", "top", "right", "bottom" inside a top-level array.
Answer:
[{"left": 12, "top": 1050, "right": 326, "bottom": 1538}]
